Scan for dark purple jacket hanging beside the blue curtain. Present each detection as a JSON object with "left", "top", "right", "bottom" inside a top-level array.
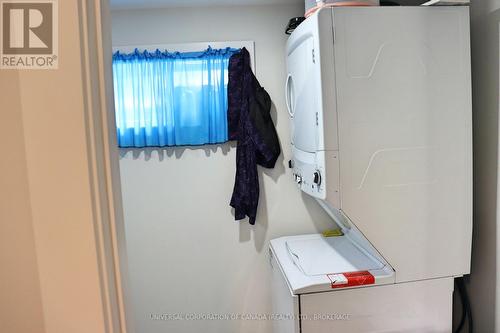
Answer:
[{"left": 228, "top": 48, "right": 281, "bottom": 224}]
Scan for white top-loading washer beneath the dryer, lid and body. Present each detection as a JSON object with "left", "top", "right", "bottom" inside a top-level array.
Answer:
[{"left": 270, "top": 235, "right": 453, "bottom": 333}]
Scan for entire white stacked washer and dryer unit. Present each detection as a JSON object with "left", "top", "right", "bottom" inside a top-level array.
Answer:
[{"left": 270, "top": 7, "right": 472, "bottom": 333}]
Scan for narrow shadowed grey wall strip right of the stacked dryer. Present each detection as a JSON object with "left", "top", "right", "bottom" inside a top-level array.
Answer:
[{"left": 469, "top": 0, "right": 500, "bottom": 332}]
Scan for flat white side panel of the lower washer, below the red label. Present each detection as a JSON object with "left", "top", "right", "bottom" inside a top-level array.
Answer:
[{"left": 300, "top": 278, "right": 453, "bottom": 333}]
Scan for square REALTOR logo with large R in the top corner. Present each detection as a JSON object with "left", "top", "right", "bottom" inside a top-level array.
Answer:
[{"left": 0, "top": 0, "right": 58, "bottom": 69}]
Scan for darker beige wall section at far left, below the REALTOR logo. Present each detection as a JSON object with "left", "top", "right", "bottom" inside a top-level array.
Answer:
[{"left": 0, "top": 70, "right": 45, "bottom": 333}]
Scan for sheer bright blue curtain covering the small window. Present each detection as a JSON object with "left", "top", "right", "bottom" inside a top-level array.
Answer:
[{"left": 113, "top": 48, "right": 239, "bottom": 148}]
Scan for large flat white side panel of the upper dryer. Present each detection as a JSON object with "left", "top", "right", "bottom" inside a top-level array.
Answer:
[{"left": 333, "top": 7, "right": 472, "bottom": 281}]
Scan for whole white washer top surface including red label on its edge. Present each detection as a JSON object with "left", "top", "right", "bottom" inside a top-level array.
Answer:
[{"left": 270, "top": 230, "right": 395, "bottom": 295}]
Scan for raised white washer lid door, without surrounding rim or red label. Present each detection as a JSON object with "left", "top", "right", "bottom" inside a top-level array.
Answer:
[{"left": 286, "top": 235, "right": 384, "bottom": 276}]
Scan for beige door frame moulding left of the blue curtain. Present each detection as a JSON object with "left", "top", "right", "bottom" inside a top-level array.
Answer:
[{"left": 78, "top": 0, "right": 133, "bottom": 333}]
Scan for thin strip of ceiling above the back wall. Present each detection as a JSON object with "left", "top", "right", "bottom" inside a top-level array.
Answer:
[{"left": 110, "top": 0, "right": 304, "bottom": 10}]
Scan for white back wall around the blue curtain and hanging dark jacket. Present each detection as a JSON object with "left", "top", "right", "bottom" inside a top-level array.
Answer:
[{"left": 112, "top": 4, "right": 331, "bottom": 333}]
